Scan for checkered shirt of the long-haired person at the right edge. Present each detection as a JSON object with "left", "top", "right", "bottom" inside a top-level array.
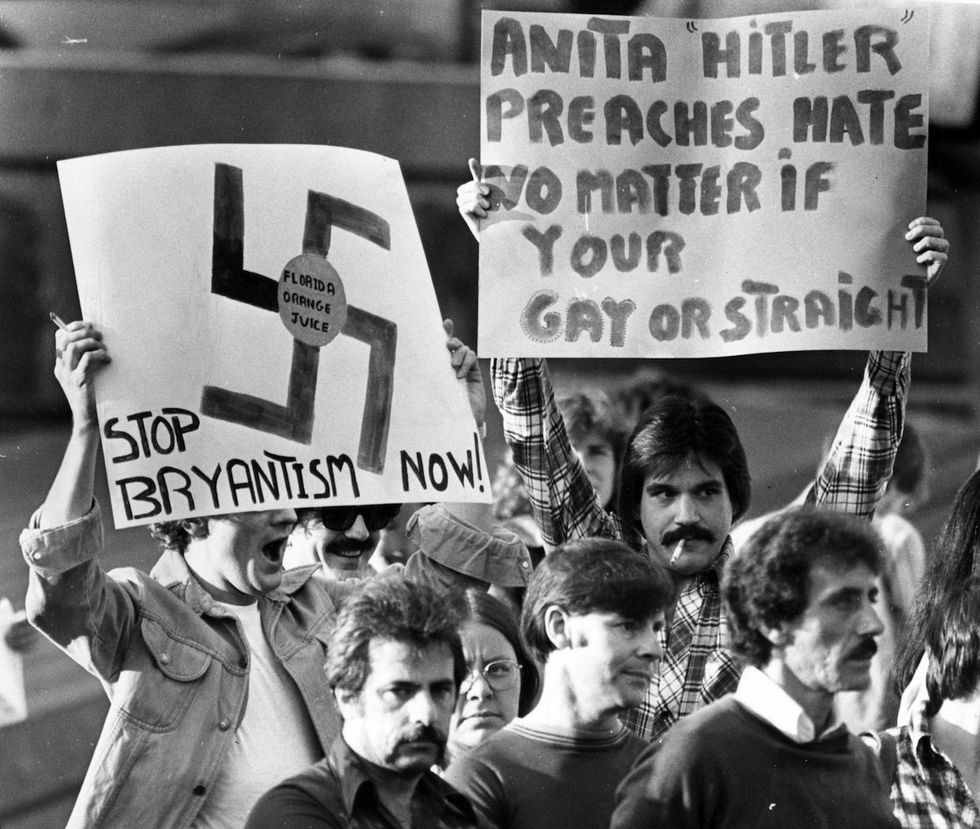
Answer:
[{"left": 889, "top": 703, "right": 980, "bottom": 829}]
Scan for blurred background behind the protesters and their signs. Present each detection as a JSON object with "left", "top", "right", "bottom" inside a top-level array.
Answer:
[{"left": 0, "top": 0, "right": 980, "bottom": 829}]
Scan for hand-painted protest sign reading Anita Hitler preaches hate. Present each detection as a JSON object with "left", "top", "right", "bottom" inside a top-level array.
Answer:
[{"left": 479, "top": 7, "right": 928, "bottom": 357}]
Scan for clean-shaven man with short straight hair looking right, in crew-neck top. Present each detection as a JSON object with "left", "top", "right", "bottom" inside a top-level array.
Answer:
[{"left": 446, "top": 538, "right": 674, "bottom": 829}]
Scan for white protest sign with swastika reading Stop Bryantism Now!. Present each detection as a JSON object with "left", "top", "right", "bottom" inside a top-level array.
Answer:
[{"left": 58, "top": 145, "right": 490, "bottom": 527}]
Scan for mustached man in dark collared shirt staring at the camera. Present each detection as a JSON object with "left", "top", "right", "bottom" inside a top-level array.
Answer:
[{"left": 246, "top": 575, "right": 477, "bottom": 829}]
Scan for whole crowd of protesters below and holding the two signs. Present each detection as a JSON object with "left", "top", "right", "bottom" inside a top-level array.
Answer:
[{"left": 21, "top": 160, "right": 980, "bottom": 829}]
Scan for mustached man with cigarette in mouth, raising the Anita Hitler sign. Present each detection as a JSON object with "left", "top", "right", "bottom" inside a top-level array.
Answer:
[{"left": 456, "top": 159, "right": 949, "bottom": 740}]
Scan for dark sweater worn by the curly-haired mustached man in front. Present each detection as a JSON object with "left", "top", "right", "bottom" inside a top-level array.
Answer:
[{"left": 610, "top": 697, "right": 898, "bottom": 829}]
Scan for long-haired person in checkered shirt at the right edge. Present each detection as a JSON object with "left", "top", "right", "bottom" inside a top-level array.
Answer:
[{"left": 880, "top": 576, "right": 980, "bottom": 829}]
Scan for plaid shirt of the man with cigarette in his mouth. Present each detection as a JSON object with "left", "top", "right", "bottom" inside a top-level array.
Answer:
[{"left": 491, "top": 351, "right": 911, "bottom": 740}]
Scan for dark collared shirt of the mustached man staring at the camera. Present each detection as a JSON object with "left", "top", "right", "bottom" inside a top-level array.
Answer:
[{"left": 246, "top": 737, "right": 477, "bottom": 829}]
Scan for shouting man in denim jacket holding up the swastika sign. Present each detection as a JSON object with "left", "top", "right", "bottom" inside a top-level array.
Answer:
[{"left": 21, "top": 322, "right": 506, "bottom": 829}]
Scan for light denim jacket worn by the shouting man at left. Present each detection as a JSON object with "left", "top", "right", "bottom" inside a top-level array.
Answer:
[{"left": 20, "top": 504, "right": 356, "bottom": 829}]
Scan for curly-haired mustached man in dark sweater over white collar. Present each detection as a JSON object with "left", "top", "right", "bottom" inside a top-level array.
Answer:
[{"left": 611, "top": 507, "right": 897, "bottom": 829}]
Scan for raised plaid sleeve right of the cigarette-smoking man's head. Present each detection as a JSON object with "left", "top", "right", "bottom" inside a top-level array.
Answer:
[{"left": 810, "top": 351, "right": 911, "bottom": 517}]
